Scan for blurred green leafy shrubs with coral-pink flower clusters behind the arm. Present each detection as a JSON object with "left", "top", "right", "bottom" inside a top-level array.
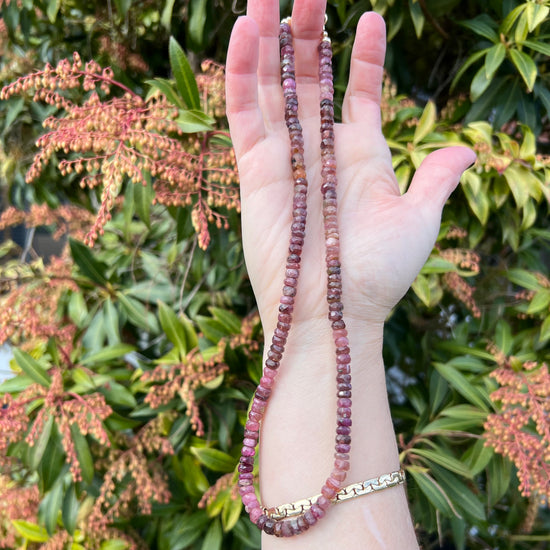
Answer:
[{"left": 0, "top": 0, "right": 550, "bottom": 550}]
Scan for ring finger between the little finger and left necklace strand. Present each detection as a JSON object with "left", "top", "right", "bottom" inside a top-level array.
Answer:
[{"left": 247, "top": 0, "right": 283, "bottom": 125}]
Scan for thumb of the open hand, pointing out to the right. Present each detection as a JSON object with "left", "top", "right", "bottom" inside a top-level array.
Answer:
[{"left": 405, "top": 146, "right": 476, "bottom": 218}]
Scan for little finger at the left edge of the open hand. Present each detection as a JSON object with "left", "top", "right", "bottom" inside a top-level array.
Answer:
[{"left": 225, "top": 17, "right": 265, "bottom": 159}]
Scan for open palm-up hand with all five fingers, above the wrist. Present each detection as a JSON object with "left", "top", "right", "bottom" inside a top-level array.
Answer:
[{"left": 227, "top": 0, "right": 475, "bottom": 334}]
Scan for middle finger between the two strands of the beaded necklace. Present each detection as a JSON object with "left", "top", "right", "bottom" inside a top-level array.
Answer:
[{"left": 291, "top": 0, "right": 326, "bottom": 118}]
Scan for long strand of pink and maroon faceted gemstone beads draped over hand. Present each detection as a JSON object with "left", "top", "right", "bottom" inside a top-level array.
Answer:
[{"left": 238, "top": 19, "right": 351, "bottom": 537}]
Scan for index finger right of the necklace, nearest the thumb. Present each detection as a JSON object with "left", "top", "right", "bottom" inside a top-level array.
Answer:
[{"left": 342, "top": 12, "right": 386, "bottom": 125}]
